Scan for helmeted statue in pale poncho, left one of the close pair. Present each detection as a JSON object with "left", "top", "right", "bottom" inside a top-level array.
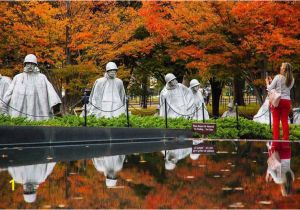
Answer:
[{"left": 160, "top": 74, "right": 195, "bottom": 118}]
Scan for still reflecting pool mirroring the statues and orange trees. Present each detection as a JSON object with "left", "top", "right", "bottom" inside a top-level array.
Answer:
[{"left": 0, "top": 139, "right": 300, "bottom": 209}]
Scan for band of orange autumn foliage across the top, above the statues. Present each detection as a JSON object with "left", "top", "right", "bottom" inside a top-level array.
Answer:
[{"left": 0, "top": 1, "right": 300, "bottom": 101}]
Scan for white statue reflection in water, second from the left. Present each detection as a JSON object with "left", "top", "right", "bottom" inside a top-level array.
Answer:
[{"left": 93, "top": 155, "right": 125, "bottom": 187}]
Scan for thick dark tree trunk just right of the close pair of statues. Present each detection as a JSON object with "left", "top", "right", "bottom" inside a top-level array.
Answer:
[{"left": 209, "top": 77, "right": 223, "bottom": 117}]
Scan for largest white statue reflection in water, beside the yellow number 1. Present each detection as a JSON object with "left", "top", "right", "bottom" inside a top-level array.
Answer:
[{"left": 7, "top": 163, "right": 55, "bottom": 203}]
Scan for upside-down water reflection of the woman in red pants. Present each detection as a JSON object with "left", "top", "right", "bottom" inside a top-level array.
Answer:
[{"left": 266, "top": 142, "right": 295, "bottom": 196}]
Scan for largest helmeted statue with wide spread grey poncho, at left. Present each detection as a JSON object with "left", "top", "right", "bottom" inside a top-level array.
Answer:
[{"left": 3, "top": 54, "right": 61, "bottom": 120}]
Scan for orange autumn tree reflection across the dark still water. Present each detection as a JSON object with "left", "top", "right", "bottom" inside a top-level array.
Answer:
[{"left": 0, "top": 142, "right": 300, "bottom": 208}]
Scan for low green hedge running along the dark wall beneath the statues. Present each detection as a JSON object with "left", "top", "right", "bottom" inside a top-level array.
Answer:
[{"left": 0, "top": 115, "right": 300, "bottom": 140}]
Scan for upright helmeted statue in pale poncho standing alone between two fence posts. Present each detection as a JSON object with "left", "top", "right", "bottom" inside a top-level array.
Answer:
[{"left": 88, "top": 62, "right": 126, "bottom": 118}]
